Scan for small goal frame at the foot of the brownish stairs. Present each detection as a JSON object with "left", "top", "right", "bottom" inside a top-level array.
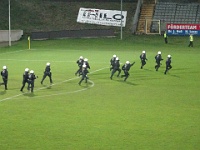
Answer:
[{"left": 145, "top": 19, "right": 161, "bottom": 34}]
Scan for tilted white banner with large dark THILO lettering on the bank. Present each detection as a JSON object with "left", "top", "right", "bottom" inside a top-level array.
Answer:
[{"left": 77, "top": 8, "right": 127, "bottom": 27}]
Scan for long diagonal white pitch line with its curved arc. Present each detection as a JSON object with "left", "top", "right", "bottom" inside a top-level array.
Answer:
[{"left": 0, "top": 67, "right": 108, "bottom": 102}]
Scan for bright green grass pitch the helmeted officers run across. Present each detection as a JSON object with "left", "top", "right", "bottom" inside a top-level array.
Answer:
[{"left": 0, "top": 36, "right": 200, "bottom": 150}]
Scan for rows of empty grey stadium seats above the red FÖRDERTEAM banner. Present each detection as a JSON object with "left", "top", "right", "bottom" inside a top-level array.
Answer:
[{"left": 151, "top": 1, "right": 200, "bottom": 31}]
